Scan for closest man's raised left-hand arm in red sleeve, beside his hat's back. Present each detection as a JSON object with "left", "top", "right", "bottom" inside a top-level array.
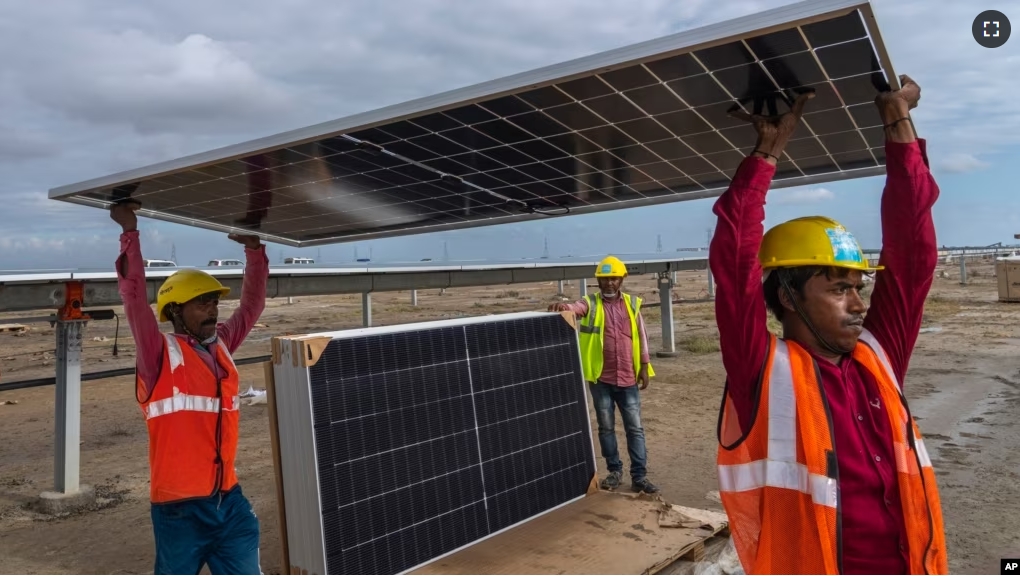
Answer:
[{"left": 708, "top": 94, "right": 813, "bottom": 423}]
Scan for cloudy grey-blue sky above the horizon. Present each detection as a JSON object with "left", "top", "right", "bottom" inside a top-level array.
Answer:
[{"left": 0, "top": 0, "right": 1020, "bottom": 269}]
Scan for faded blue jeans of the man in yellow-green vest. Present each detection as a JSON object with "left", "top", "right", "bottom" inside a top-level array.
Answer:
[{"left": 589, "top": 382, "right": 648, "bottom": 481}]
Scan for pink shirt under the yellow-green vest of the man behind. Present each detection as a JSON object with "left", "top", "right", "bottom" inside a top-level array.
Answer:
[{"left": 567, "top": 293, "right": 649, "bottom": 387}]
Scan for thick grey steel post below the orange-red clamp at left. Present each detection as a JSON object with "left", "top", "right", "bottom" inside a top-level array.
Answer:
[{"left": 53, "top": 320, "right": 87, "bottom": 494}]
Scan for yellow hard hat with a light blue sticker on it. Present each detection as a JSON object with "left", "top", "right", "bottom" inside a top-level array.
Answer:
[{"left": 758, "top": 216, "right": 882, "bottom": 272}]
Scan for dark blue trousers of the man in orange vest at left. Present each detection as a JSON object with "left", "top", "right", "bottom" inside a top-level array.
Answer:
[{"left": 152, "top": 485, "right": 262, "bottom": 574}]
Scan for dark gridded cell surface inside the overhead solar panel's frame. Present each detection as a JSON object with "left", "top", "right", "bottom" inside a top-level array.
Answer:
[{"left": 57, "top": 2, "right": 890, "bottom": 245}]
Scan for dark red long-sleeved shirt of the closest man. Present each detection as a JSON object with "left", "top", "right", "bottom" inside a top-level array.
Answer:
[{"left": 709, "top": 140, "right": 938, "bottom": 574}]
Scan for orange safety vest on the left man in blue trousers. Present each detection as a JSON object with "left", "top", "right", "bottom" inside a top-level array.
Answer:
[{"left": 136, "top": 334, "right": 241, "bottom": 504}]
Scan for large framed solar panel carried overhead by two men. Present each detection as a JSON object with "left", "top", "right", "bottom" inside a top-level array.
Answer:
[{"left": 50, "top": 0, "right": 898, "bottom": 247}]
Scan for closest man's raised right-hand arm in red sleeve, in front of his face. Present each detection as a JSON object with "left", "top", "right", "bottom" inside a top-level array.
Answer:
[{"left": 864, "top": 75, "right": 938, "bottom": 383}]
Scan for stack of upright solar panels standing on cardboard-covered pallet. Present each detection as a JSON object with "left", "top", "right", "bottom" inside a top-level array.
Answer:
[{"left": 274, "top": 313, "right": 596, "bottom": 574}]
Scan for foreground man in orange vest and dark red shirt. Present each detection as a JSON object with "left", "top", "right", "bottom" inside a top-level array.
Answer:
[{"left": 709, "top": 76, "right": 948, "bottom": 574}]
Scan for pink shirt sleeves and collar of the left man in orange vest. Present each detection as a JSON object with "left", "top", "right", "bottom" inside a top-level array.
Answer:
[{"left": 116, "top": 230, "right": 269, "bottom": 389}]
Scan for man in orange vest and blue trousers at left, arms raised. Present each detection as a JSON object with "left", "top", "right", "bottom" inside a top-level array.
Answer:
[{"left": 110, "top": 203, "right": 269, "bottom": 574}]
